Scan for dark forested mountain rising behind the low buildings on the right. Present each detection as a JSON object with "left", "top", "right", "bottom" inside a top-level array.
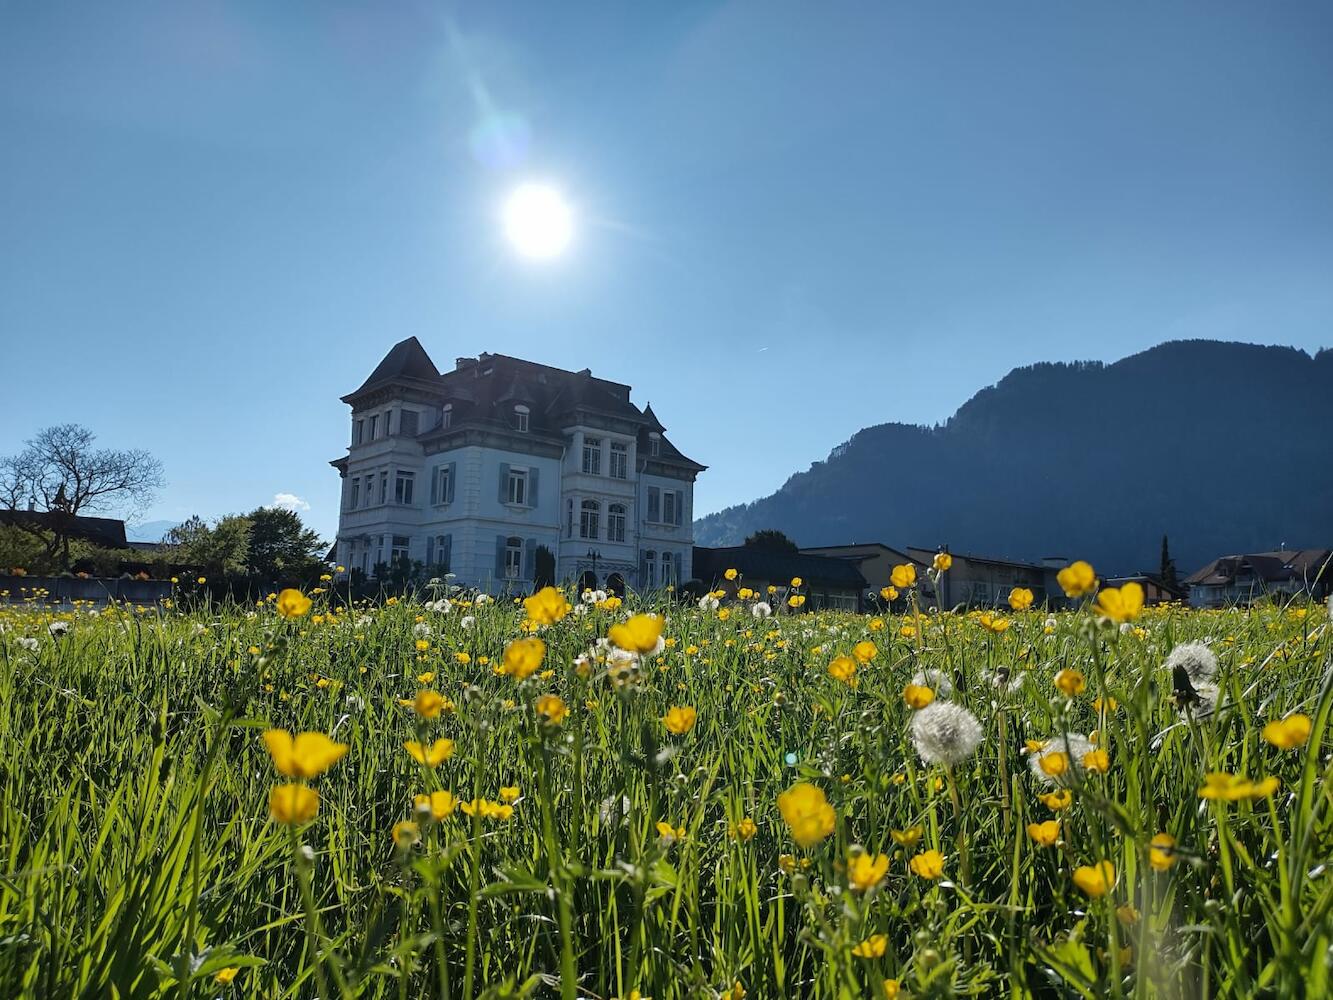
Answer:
[{"left": 694, "top": 340, "right": 1333, "bottom": 575}]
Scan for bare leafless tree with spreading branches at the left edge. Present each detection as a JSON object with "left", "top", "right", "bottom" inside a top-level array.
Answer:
[{"left": 0, "top": 424, "right": 163, "bottom": 565}]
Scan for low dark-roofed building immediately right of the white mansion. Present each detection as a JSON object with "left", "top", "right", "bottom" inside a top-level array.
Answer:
[{"left": 694, "top": 545, "right": 866, "bottom": 611}]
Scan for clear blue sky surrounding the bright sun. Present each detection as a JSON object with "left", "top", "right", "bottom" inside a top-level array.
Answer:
[{"left": 0, "top": 0, "right": 1333, "bottom": 536}]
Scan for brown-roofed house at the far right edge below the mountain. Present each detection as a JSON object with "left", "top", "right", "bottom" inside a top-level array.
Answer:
[{"left": 1185, "top": 548, "right": 1333, "bottom": 608}]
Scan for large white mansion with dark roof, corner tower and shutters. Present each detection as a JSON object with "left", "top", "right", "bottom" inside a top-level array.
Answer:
[{"left": 331, "top": 337, "right": 706, "bottom": 592}]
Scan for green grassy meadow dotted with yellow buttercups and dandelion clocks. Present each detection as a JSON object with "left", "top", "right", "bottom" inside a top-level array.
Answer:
[{"left": 0, "top": 568, "right": 1333, "bottom": 1000}]
